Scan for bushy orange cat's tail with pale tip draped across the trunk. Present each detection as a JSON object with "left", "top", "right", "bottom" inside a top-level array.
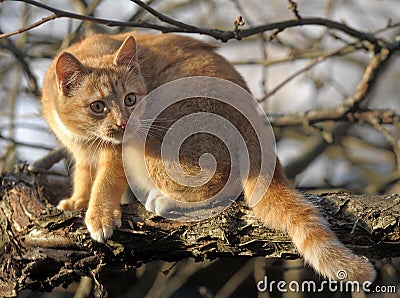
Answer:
[{"left": 244, "top": 161, "right": 376, "bottom": 282}]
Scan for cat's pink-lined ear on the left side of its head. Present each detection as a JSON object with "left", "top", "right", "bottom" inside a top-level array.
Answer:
[{"left": 56, "top": 52, "right": 87, "bottom": 96}]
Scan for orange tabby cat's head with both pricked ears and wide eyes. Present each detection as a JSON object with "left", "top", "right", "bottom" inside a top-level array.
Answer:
[{"left": 55, "top": 36, "right": 146, "bottom": 144}]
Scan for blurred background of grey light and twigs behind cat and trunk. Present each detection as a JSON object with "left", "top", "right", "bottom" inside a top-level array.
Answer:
[{"left": 0, "top": 0, "right": 400, "bottom": 297}]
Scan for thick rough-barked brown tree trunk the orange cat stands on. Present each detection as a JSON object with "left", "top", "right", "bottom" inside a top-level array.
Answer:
[{"left": 0, "top": 165, "right": 400, "bottom": 297}]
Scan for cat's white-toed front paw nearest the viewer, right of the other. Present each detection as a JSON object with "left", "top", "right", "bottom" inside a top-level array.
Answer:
[{"left": 85, "top": 207, "right": 122, "bottom": 242}]
